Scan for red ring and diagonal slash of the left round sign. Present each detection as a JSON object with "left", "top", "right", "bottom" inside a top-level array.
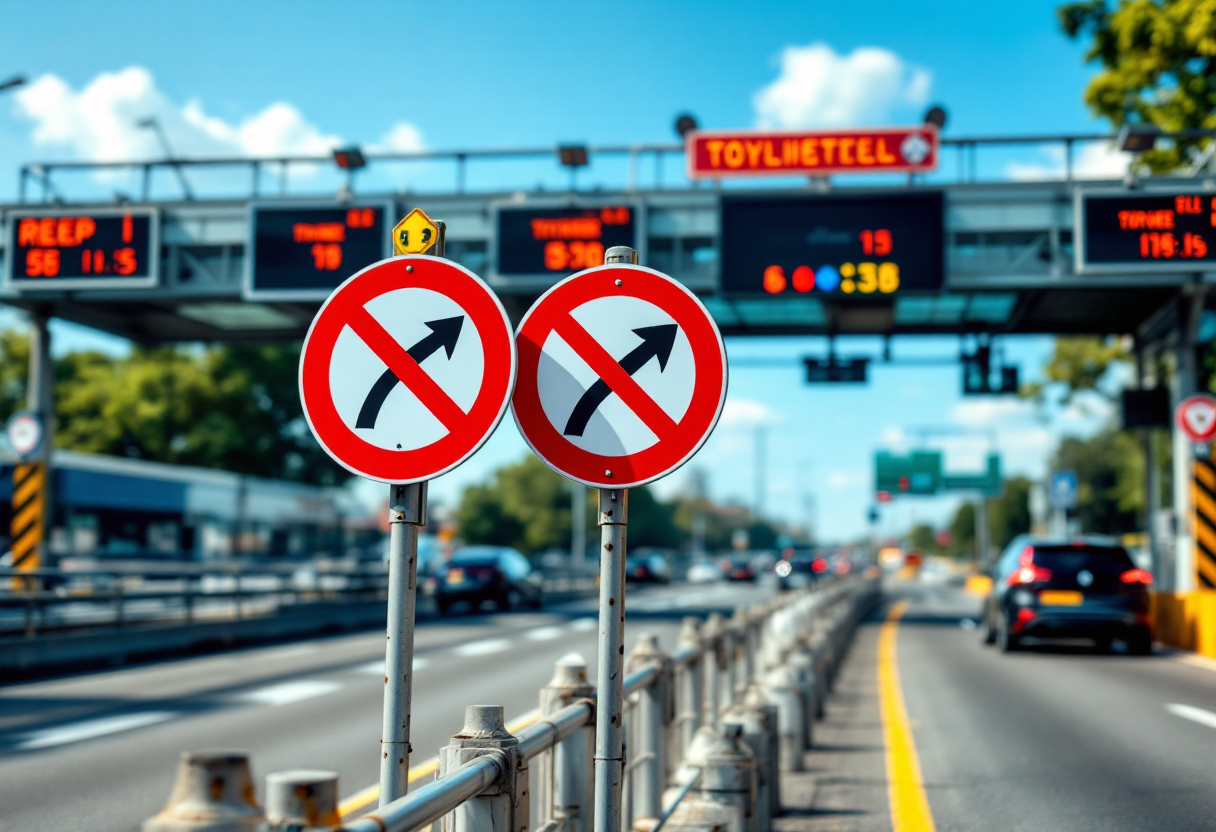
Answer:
[{"left": 299, "top": 254, "right": 516, "bottom": 483}]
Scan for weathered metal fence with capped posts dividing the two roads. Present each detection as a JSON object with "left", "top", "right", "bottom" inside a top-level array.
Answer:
[{"left": 143, "top": 577, "right": 879, "bottom": 832}]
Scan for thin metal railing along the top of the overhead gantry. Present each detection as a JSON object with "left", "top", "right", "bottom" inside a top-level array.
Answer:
[{"left": 17, "top": 129, "right": 1216, "bottom": 203}]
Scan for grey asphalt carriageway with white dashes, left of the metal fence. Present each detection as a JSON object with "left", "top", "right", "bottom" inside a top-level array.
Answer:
[{"left": 0, "top": 584, "right": 771, "bottom": 832}]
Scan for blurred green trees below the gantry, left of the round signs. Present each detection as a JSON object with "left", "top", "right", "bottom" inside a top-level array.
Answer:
[{"left": 0, "top": 330, "right": 349, "bottom": 484}]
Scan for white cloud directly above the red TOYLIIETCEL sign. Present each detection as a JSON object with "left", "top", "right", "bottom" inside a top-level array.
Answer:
[{"left": 753, "top": 43, "right": 931, "bottom": 128}]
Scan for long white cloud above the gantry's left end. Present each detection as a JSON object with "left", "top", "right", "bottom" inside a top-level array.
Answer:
[{"left": 16, "top": 67, "right": 422, "bottom": 162}]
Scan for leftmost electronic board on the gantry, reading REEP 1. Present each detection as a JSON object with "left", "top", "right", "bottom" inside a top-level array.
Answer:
[{"left": 5, "top": 208, "right": 158, "bottom": 292}]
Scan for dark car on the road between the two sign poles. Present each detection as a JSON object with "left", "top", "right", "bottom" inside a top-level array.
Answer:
[{"left": 435, "top": 546, "right": 542, "bottom": 614}]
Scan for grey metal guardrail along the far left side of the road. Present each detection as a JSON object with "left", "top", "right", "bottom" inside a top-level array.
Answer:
[{"left": 0, "top": 562, "right": 595, "bottom": 637}]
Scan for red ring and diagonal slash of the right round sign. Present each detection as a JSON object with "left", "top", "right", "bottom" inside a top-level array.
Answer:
[{"left": 511, "top": 265, "right": 727, "bottom": 488}]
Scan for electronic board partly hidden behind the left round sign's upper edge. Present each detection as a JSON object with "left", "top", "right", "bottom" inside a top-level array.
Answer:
[{"left": 244, "top": 202, "right": 396, "bottom": 300}]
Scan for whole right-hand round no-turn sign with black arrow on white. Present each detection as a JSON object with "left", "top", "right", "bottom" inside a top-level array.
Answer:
[{"left": 512, "top": 265, "right": 727, "bottom": 488}]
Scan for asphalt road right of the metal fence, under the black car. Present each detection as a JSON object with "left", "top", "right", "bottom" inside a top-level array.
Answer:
[{"left": 777, "top": 584, "right": 1216, "bottom": 832}]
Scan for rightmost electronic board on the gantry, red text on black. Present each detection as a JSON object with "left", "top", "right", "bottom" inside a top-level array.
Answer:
[{"left": 1075, "top": 191, "right": 1216, "bottom": 274}]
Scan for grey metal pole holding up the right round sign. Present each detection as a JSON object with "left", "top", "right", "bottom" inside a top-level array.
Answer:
[{"left": 595, "top": 488, "right": 629, "bottom": 832}]
